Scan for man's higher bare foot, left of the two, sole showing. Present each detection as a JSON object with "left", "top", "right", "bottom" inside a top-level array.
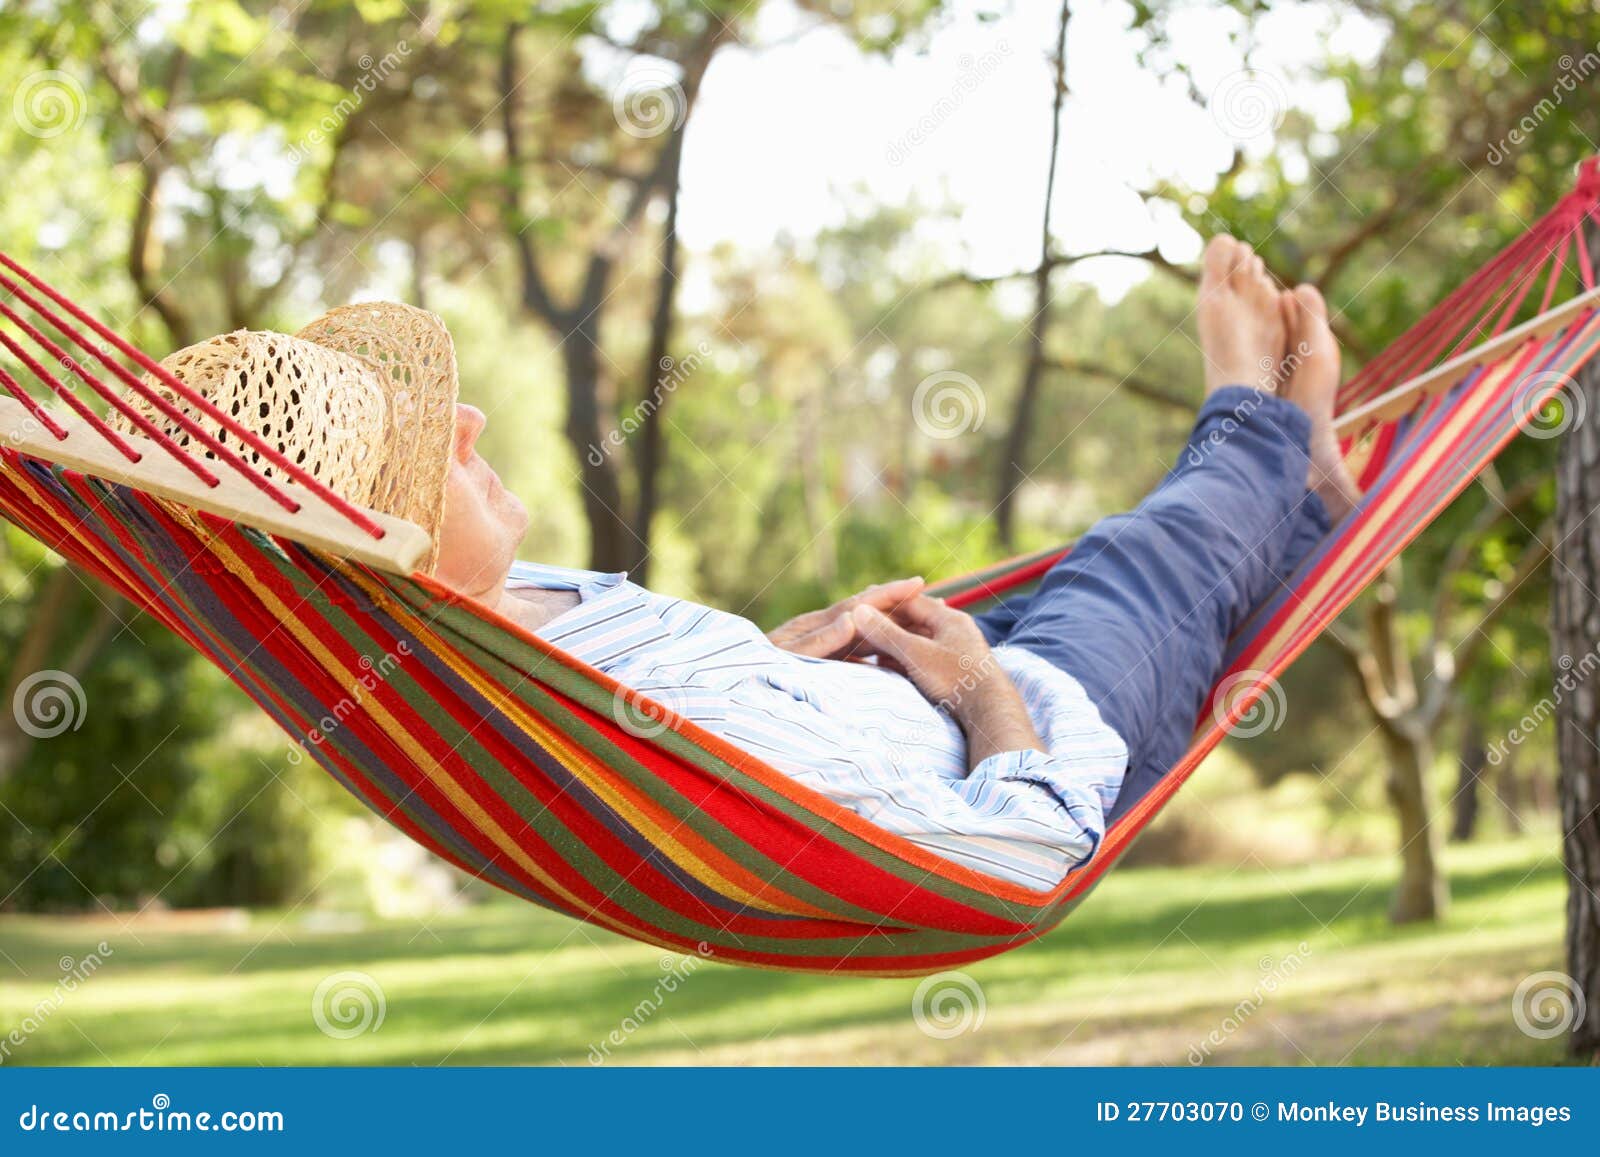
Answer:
[{"left": 1197, "top": 234, "right": 1286, "bottom": 395}]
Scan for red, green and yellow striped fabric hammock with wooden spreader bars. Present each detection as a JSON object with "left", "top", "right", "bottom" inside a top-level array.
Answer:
[{"left": 0, "top": 162, "right": 1600, "bottom": 975}]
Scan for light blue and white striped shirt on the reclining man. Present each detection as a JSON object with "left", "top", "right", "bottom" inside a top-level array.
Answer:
[{"left": 506, "top": 563, "right": 1128, "bottom": 888}]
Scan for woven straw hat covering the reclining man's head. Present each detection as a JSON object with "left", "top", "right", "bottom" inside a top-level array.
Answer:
[{"left": 117, "top": 302, "right": 458, "bottom": 570}]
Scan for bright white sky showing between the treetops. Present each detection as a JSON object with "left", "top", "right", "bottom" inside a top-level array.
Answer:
[{"left": 611, "top": 0, "right": 1382, "bottom": 298}]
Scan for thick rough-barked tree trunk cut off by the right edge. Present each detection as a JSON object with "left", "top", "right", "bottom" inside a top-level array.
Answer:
[{"left": 1550, "top": 332, "right": 1600, "bottom": 1061}]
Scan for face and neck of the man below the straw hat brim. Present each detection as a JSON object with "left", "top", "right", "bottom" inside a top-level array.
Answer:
[{"left": 434, "top": 405, "right": 528, "bottom": 605}]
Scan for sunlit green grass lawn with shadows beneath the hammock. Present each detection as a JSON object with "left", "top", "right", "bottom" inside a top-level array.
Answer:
[{"left": 0, "top": 835, "right": 1566, "bottom": 1066}]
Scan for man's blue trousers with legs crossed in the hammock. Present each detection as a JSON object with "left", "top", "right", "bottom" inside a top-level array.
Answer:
[{"left": 978, "top": 386, "right": 1330, "bottom": 818}]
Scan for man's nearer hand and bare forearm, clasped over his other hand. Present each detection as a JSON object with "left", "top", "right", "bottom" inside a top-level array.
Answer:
[{"left": 851, "top": 595, "right": 1045, "bottom": 770}]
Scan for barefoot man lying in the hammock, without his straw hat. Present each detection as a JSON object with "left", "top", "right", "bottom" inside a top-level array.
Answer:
[{"left": 419, "top": 237, "right": 1358, "bottom": 888}]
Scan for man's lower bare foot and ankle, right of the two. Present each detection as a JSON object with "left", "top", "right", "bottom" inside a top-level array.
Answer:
[{"left": 1282, "top": 285, "right": 1362, "bottom": 522}]
